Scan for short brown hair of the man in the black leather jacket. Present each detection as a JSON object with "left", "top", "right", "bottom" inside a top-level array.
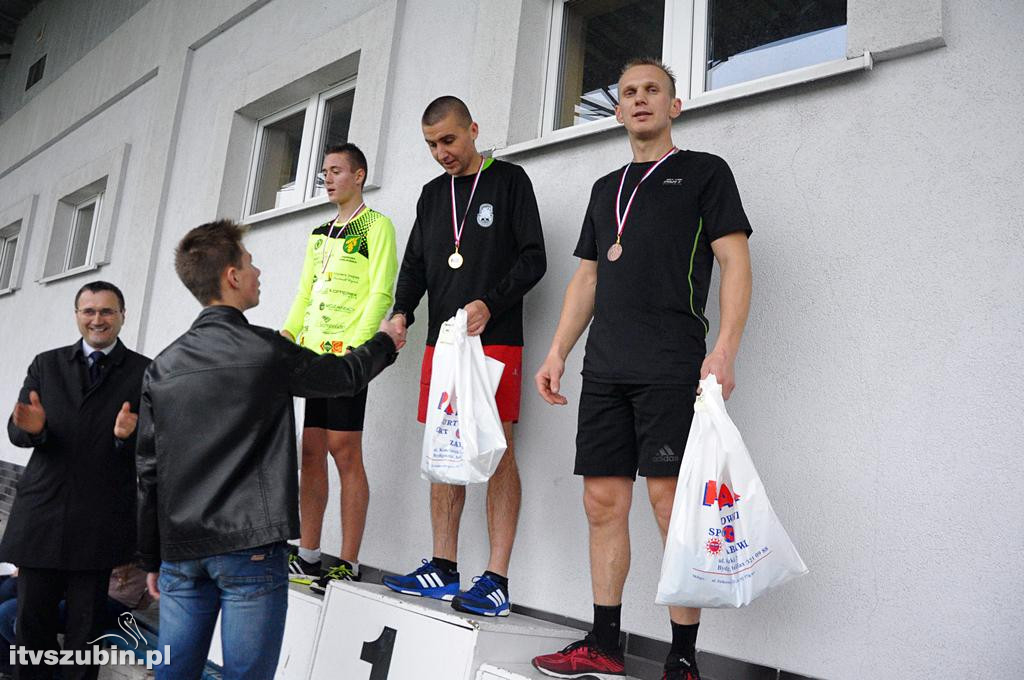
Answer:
[{"left": 174, "top": 219, "right": 246, "bottom": 305}]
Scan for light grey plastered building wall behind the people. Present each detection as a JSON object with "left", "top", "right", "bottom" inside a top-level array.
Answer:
[{"left": 0, "top": 0, "right": 1024, "bottom": 678}]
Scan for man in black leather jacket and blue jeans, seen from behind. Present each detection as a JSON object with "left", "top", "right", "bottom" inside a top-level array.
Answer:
[{"left": 137, "top": 220, "right": 400, "bottom": 680}]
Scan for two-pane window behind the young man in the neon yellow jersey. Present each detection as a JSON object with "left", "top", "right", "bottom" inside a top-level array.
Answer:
[{"left": 246, "top": 79, "right": 355, "bottom": 216}]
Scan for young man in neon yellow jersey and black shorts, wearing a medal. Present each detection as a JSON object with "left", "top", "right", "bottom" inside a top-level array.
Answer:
[{"left": 281, "top": 143, "right": 398, "bottom": 592}]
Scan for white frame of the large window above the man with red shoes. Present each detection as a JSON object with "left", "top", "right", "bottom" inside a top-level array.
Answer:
[{"left": 540, "top": 0, "right": 849, "bottom": 137}]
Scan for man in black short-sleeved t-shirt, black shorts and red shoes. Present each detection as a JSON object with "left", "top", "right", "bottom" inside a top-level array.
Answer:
[{"left": 534, "top": 59, "right": 751, "bottom": 680}]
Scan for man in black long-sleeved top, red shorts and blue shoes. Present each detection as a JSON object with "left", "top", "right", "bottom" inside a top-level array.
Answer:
[{"left": 384, "top": 96, "right": 547, "bottom": 617}]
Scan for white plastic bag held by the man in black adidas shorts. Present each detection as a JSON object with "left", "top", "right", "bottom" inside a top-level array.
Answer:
[{"left": 655, "top": 375, "right": 807, "bottom": 607}]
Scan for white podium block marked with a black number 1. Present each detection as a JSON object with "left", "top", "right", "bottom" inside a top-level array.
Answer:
[{"left": 308, "top": 581, "right": 581, "bottom": 680}]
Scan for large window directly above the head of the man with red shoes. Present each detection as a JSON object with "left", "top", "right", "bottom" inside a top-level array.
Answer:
[{"left": 545, "top": 0, "right": 846, "bottom": 129}]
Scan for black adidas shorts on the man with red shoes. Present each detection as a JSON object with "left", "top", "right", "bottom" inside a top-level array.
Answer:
[{"left": 574, "top": 378, "right": 697, "bottom": 479}]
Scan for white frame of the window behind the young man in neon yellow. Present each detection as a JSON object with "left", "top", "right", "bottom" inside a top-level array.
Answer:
[{"left": 242, "top": 75, "right": 357, "bottom": 221}]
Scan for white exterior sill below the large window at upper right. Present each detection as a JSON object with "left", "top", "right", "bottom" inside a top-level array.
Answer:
[{"left": 494, "top": 52, "right": 873, "bottom": 158}]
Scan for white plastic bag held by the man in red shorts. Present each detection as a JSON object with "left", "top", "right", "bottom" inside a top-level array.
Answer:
[{"left": 420, "top": 309, "right": 507, "bottom": 484}]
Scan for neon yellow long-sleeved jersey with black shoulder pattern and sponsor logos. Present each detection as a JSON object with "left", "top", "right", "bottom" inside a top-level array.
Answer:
[{"left": 285, "top": 208, "right": 398, "bottom": 354}]
